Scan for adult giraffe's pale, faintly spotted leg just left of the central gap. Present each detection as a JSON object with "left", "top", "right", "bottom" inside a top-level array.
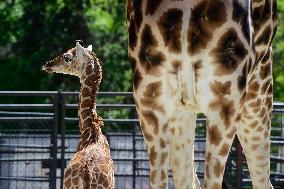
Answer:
[{"left": 168, "top": 107, "right": 200, "bottom": 189}]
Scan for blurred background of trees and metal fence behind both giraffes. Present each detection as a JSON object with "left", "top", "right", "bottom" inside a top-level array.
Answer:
[{"left": 0, "top": 0, "right": 284, "bottom": 189}]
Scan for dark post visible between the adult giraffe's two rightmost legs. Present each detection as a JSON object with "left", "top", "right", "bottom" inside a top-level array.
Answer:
[{"left": 236, "top": 138, "right": 243, "bottom": 189}]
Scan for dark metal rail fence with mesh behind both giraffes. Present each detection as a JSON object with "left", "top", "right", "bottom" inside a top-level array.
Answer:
[{"left": 0, "top": 91, "right": 284, "bottom": 189}]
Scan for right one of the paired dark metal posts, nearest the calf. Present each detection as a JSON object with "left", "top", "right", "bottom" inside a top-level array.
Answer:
[{"left": 59, "top": 92, "right": 66, "bottom": 188}]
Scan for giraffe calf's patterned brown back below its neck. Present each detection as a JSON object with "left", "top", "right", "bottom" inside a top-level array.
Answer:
[{"left": 64, "top": 134, "right": 115, "bottom": 189}]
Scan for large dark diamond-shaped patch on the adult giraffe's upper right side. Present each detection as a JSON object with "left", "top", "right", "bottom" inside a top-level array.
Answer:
[{"left": 211, "top": 28, "right": 248, "bottom": 76}]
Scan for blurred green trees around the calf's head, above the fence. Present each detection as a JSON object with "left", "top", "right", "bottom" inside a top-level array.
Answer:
[{"left": 0, "top": 0, "right": 131, "bottom": 91}]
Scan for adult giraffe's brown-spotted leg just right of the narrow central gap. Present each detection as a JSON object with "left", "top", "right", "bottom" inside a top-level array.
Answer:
[{"left": 197, "top": 75, "right": 241, "bottom": 189}]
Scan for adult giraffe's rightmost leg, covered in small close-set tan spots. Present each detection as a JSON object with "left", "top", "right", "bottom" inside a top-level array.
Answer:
[{"left": 237, "top": 51, "right": 273, "bottom": 189}]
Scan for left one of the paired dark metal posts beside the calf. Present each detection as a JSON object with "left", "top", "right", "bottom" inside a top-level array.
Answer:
[{"left": 49, "top": 93, "right": 59, "bottom": 189}]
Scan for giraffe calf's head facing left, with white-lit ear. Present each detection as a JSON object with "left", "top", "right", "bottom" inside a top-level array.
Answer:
[{"left": 42, "top": 42, "right": 92, "bottom": 77}]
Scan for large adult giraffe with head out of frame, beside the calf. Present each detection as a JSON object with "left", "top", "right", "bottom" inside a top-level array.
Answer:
[{"left": 127, "top": 0, "right": 277, "bottom": 189}]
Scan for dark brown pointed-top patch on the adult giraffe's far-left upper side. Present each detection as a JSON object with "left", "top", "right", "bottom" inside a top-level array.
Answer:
[{"left": 138, "top": 24, "right": 165, "bottom": 76}]
